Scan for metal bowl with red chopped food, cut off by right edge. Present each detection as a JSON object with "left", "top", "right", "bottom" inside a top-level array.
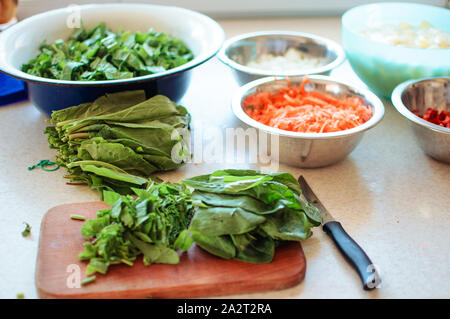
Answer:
[{"left": 392, "top": 77, "right": 450, "bottom": 164}]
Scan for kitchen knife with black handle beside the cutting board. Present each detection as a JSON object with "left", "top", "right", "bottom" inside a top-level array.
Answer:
[{"left": 298, "top": 176, "right": 381, "bottom": 290}]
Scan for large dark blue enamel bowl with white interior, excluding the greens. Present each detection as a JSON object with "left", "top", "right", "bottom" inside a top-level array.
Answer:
[{"left": 0, "top": 3, "right": 224, "bottom": 116}]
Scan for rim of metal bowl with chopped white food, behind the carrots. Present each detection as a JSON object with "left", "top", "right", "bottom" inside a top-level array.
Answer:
[{"left": 217, "top": 30, "right": 345, "bottom": 76}]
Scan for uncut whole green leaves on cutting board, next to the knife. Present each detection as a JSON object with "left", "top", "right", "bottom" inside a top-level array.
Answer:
[{"left": 182, "top": 169, "right": 322, "bottom": 263}]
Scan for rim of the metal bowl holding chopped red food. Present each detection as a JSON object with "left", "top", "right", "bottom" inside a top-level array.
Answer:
[{"left": 391, "top": 76, "right": 450, "bottom": 134}]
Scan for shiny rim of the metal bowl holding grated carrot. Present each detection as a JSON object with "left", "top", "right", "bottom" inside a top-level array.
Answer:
[{"left": 231, "top": 75, "right": 384, "bottom": 140}]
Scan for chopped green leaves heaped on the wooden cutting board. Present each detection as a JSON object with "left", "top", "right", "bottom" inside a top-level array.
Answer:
[{"left": 78, "top": 182, "right": 194, "bottom": 276}]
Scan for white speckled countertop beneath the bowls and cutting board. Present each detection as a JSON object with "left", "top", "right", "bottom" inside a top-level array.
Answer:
[{"left": 0, "top": 18, "right": 450, "bottom": 298}]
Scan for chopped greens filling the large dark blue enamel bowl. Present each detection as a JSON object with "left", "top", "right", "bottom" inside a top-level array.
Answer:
[{"left": 22, "top": 22, "right": 194, "bottom": 81}]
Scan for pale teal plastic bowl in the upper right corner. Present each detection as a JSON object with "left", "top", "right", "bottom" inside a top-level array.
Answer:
[{"left": 342, "top": 2, "right": 450, "bottom": 98}]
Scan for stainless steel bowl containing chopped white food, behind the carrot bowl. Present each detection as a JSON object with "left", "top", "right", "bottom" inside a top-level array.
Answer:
[{"left": 217, "top": 31, "right": 345, "bottom": 85}]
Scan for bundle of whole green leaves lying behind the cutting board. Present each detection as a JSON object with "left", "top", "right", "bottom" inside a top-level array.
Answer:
[{"left": 44, "top": 91, "right": 190, "bottom": 198}]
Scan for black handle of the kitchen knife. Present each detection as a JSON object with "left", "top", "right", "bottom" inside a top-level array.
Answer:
[{"left": 323, "top": 221, "right": 381, "bottom": 290}]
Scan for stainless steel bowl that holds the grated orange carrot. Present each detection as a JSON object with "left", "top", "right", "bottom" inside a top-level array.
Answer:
[{"left": 232, "top": 75, "right": 384, "bottom": 168}]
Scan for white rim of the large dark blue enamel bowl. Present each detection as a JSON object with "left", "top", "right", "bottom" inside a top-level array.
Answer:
[{"left": 0, "top": 3, "right": 225, "bottom": 87}]
